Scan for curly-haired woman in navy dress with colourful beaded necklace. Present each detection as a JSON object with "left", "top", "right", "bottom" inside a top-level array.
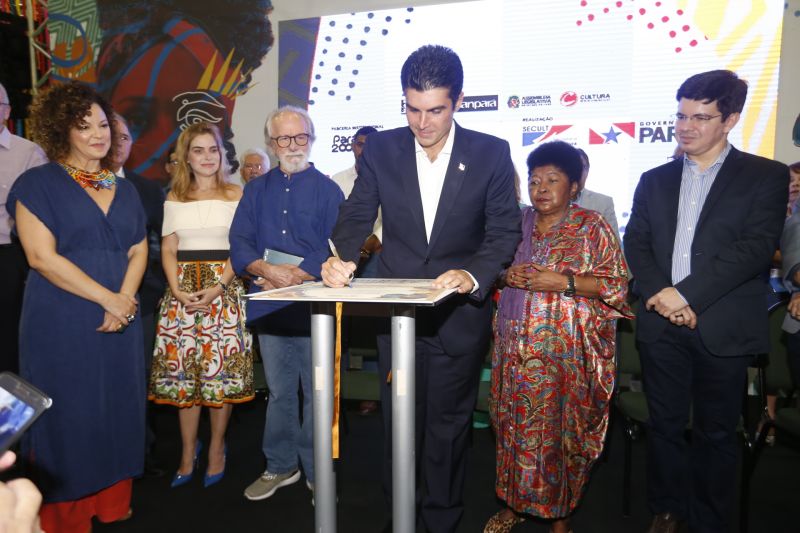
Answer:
[{"left": 6, "top": 82, "right": 147, "bottom": 533}]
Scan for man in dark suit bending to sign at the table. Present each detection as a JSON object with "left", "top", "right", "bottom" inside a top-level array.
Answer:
[{"left": 322, "top": 46, "right": 520, "bottom": 533}]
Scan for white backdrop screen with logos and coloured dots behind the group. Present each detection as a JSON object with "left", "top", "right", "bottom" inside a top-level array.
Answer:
[{"left": 280, "top": 0, "right": 783, "bottom": 233}]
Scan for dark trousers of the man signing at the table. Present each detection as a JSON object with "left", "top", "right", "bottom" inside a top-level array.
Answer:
[{"left": 378, "top": 330, "right": 486, "bottom": 533}]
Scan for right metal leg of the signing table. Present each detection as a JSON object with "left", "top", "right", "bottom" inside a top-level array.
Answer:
[{"left": 392, "top": 306, "right": 416, "bottom": 533}]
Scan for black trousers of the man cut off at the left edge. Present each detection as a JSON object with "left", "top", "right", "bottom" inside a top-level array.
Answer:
[{"left": 0, "top": 243, "right": 28, "bottom": 373}]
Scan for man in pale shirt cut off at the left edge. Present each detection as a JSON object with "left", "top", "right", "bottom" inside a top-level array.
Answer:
[{"left": 0, "top": 84, "right": 47, "bottom": 372}]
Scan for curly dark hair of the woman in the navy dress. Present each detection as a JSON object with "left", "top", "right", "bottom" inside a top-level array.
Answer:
[{"left": 28, "top": 81, "right": 117, "bottom": 169}]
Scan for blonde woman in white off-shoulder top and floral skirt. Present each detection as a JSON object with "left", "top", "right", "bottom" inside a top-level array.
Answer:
[{"left": 149, "top": 122, "right": 253, "bottom": 488}]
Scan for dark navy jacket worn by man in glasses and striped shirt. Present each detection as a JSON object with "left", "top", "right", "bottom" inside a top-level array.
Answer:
[{"left": 624, "top": 148, "right": 789, "bottom": 356}]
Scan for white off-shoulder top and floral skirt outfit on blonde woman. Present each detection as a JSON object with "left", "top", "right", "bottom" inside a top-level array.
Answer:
[{"left": 148, "top": 200, "right": 254, "bottom": 407}]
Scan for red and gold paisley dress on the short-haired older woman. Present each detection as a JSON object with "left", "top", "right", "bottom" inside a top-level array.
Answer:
[{"left": 489, "top": 206, "right": 631, "bottom": 518}]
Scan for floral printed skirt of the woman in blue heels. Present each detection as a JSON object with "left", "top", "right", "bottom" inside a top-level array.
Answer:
[{"left": 148, "top": 257, "right": 254, "bottom": 407}]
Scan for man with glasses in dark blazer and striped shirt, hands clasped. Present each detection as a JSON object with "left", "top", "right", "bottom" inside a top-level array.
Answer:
[{"left": 624, "top": 70, "right": 789, "bottom": 533}]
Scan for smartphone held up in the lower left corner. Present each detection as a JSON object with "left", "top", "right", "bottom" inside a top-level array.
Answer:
[{"left": 0, "top": 372, "right": 53, "bottom": 455}]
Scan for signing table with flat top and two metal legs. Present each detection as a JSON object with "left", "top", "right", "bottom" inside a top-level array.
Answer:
[{"left": 249, "top": 279, "right": 455, "bottom": 533}]
